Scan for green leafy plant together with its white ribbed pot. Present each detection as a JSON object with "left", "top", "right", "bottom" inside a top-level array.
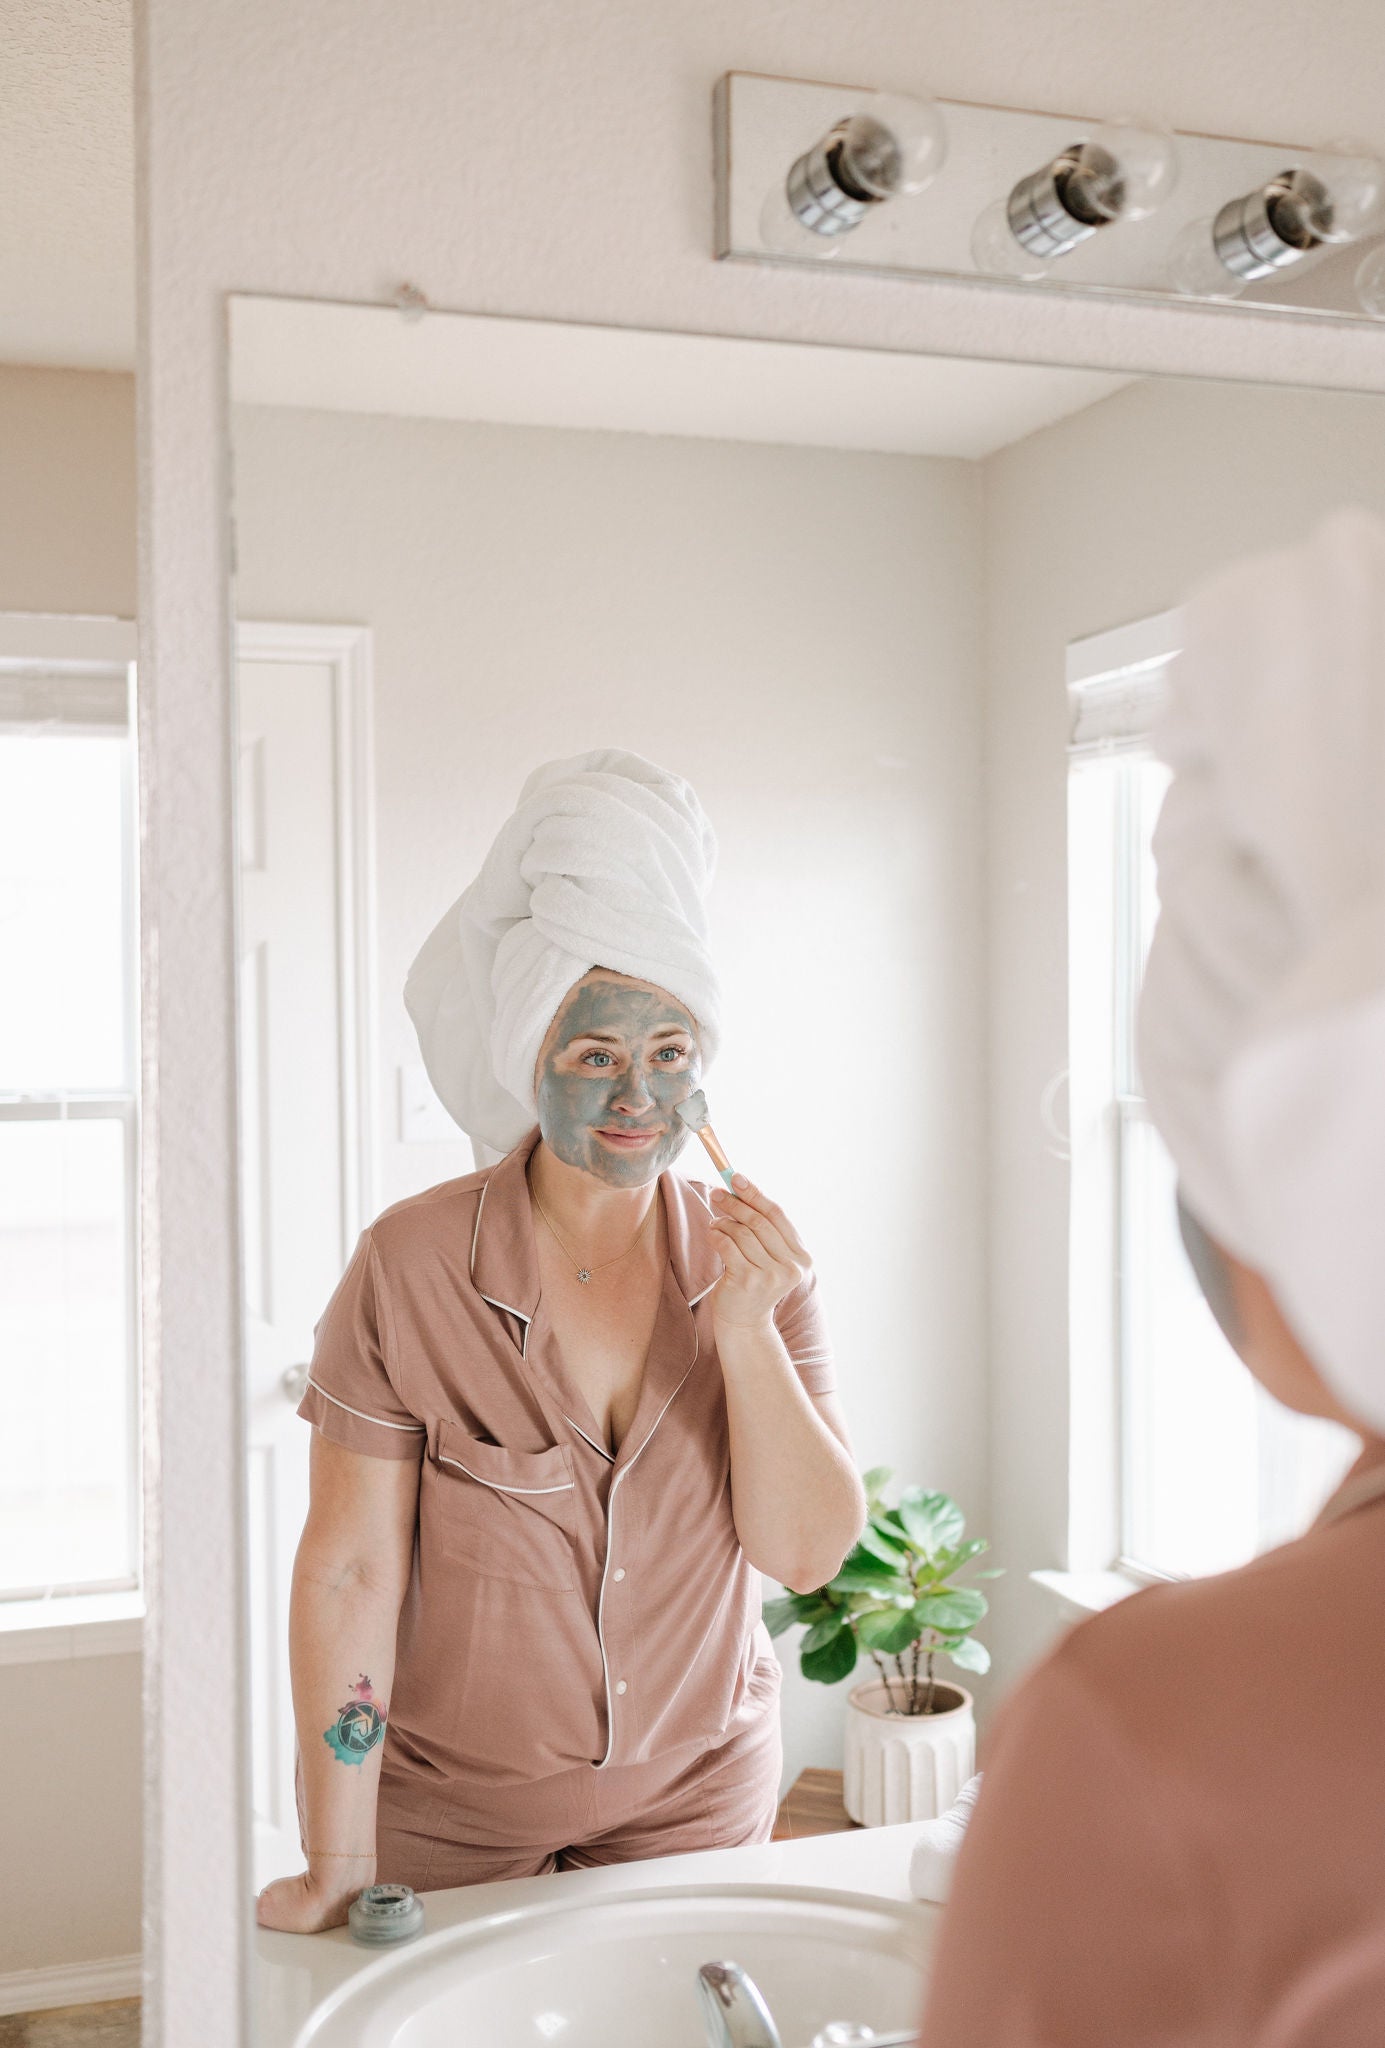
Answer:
[{"left": 764, "top": 1466, "right": 998, "bottom": 1827}]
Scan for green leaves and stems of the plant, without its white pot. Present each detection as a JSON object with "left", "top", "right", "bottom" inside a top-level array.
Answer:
[{"left": 764, "top": 1464, "right": 1000, "bottom": 1714}]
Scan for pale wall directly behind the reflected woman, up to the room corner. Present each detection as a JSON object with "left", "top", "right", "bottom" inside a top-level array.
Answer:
[{"left": 236, "top": 410, "right": 985, "bottom": 1776}]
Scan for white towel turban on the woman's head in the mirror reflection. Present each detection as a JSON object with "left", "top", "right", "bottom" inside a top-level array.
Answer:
[{"left": 404, "top": 750, "right": 721, "bottom": 1153}]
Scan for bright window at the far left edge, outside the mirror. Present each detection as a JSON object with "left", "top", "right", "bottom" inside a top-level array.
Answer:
[{"left": 0, "top": 638, "right": 139, "bottom": 1602}]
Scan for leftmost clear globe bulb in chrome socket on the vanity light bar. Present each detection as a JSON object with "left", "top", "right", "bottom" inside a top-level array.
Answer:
[{"left": 760, "top": 92, "right": 947, "bottom": 258}]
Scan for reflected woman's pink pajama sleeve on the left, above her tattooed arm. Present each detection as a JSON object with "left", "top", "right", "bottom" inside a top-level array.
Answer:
[{"left": 299, "top": 1231, "right": 426, "bottom": 1458}]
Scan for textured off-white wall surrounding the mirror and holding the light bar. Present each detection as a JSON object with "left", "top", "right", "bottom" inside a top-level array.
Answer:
[{"left": 137, "top": 0, "right": 1385, "bottom": 2048}]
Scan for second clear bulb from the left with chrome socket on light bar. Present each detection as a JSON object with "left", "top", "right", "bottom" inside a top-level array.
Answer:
[{"left": 971, "top": 123, "right": 1178, "bottom": 279}]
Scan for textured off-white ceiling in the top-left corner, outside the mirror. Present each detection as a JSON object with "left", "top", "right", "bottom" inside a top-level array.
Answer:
[{"left": 0, "top": 0, "right": 135, "bottom": 369}]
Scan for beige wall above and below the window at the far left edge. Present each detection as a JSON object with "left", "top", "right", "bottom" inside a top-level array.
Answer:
[{"left": 0, "top": 367, "right": 141, "bottom": 1972}]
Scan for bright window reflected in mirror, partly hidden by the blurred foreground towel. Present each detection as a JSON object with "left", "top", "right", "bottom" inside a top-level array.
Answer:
[{"left": 1067, "top": 614, "right": 1354, "bottom": 1577}]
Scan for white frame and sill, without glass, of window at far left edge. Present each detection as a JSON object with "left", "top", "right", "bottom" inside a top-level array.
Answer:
[{"left": 0, "top": 612, "right": 143, "bottom": 1665}]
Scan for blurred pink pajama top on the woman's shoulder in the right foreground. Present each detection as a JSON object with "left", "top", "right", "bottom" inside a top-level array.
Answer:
[{"left": 920, "top": 1438, "right": 1385, "bottom": 2048}]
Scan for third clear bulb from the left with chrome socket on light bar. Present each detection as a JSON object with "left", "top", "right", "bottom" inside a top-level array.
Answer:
[{"left": 1170, "top": 150, "right": 1385, "bottom": 299}]
